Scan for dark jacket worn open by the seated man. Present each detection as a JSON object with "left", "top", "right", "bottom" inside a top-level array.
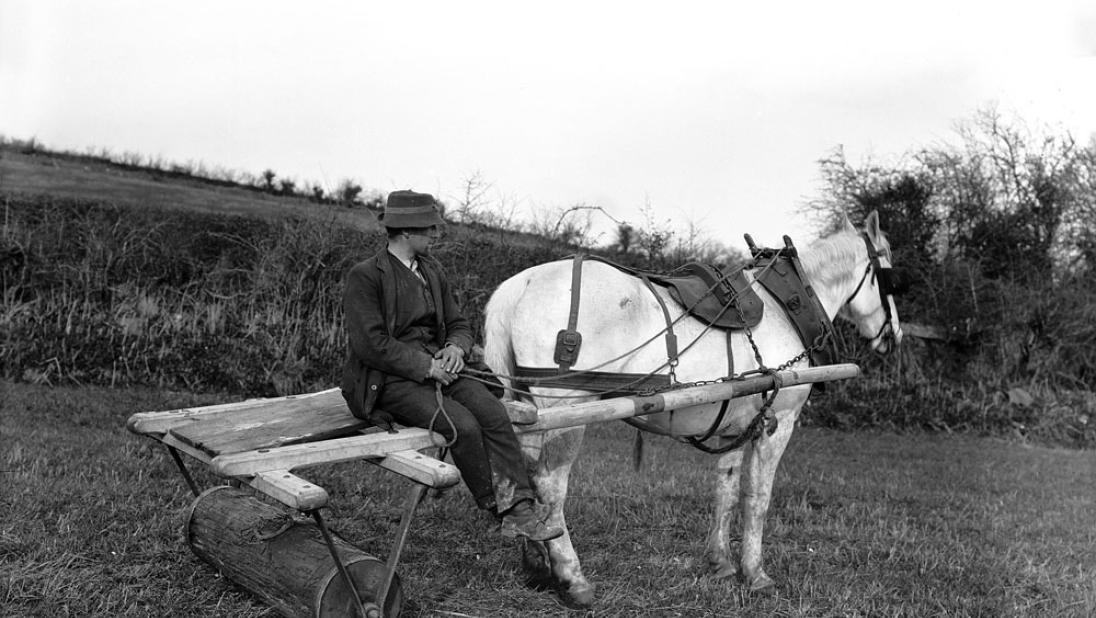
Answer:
[{"left": 342, "top": 249, "right": 472, "bottom": 421}]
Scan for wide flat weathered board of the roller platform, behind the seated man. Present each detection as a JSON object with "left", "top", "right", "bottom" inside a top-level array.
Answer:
[{"left": 168, "top": 390, "right": 369, "bottom": 457}]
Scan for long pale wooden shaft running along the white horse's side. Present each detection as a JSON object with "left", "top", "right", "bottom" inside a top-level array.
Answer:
[{"left": 514, "top": 364, "right": 860, "bottom": 433}]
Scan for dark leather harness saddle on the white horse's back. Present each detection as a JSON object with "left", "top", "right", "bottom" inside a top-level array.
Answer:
[{"left": 651, "top": 263, "right": 765, "bottom": 329}]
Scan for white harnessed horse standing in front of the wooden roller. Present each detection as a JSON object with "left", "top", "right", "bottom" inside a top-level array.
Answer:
[{"left": 484, "top": 213, "right": 901, "bottom": 607}]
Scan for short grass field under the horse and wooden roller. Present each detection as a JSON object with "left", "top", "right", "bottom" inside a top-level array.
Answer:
[{"left": 0, "top": 381, "right": 1096, "bottom": 617}]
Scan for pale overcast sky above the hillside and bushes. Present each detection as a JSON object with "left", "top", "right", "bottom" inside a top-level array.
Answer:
[{"left": 0, "top": 0, "right": 1096, "bottom": 248}]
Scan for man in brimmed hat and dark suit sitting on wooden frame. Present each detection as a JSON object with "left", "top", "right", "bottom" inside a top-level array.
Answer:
[{"left": 342, "top": 191, "right": 563, "bottom": 540}]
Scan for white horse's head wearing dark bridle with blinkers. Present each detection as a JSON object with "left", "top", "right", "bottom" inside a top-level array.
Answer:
[{"left": 838, "top": 211, "right": 910, "bottom": 354}]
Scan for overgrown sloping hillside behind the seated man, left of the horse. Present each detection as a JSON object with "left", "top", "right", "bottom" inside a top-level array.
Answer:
[{"left": 0, "top": 143, "right": 570, "bottom": 394}]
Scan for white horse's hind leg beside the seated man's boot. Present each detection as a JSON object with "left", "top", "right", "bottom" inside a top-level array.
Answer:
[{"left": 524, "top": 426, "right": 594, "bottom": 608}]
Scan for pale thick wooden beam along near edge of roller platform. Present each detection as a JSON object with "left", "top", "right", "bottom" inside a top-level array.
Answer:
[{"left": 210, "top": 427, "right": 444, "bottom": 477}]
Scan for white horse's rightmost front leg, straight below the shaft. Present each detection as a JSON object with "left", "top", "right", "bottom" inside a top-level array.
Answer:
[{"left": 741, "top": 412, "right": 797, "bottom": 591}]
